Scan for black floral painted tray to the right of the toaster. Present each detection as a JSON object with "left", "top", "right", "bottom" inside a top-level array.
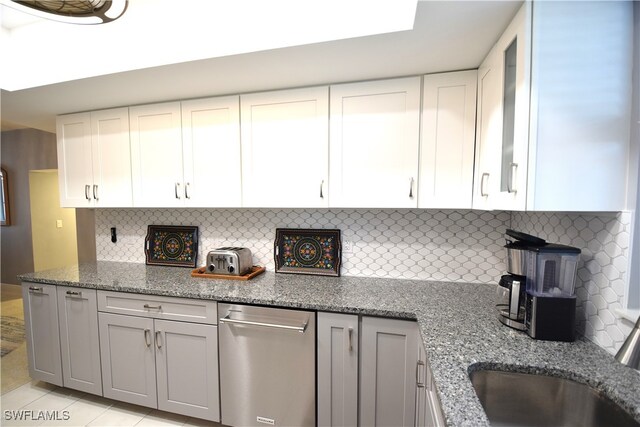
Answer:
[{"left": 274, "top": 228, "right": 342, "bottom": 276}]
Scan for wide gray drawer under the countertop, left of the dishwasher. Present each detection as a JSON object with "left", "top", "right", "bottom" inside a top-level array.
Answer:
[{"left": 98, "top": 291, "right": 218, "bottom": 325}]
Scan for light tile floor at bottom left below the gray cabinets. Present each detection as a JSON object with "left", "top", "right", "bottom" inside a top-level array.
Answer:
[{"left": 0, "top": 381, "right": 222, "bottom": 427}]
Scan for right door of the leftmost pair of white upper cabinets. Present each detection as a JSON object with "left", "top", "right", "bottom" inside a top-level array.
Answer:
[{"left": 91, "top": 107, "right": 133, "bottom": 208}]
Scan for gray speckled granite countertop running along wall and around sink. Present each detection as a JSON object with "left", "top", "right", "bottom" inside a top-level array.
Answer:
[{"left": 19, "top": 261, "right": 640, "bottom": 426}]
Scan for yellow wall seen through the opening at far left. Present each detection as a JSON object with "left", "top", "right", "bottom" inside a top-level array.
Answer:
[{"left": 29, "top": 169, "right": 78, "bottom": 271}]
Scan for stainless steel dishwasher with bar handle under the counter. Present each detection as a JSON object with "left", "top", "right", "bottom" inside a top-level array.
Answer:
[{"left": 218, "top": 304, "right": 316, "bottom": 426}]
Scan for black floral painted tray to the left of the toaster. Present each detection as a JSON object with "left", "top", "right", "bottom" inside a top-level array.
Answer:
[{"left": 144, "top": 225, "right": 198, "bottom": 268}]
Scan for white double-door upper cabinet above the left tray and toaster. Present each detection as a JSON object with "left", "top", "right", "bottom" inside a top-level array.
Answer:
[{"left": 130, "top": 96, "right": 241, "bottom": 207}]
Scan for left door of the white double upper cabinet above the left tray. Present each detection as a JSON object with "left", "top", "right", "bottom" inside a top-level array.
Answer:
[{"left": 129, "top": 102, "right": 184, "bottom": 207}]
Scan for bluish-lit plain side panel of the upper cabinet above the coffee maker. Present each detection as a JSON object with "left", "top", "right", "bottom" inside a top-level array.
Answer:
[{"left": 527, "top": 1, "right": 638, "bottom": 211}]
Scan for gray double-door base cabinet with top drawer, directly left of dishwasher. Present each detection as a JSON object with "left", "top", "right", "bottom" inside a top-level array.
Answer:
[{"left": 98, "top": 292, "right": 220, "bottom": 422}]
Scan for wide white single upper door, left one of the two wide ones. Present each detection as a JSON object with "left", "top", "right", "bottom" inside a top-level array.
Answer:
[{"left": 240, "top": 87, "right": 329, "bottom": 208}]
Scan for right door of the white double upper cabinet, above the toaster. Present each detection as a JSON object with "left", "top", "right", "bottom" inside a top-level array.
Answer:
[{"left": 182, "top": 96, "right": 242, "bottom": 207}]
